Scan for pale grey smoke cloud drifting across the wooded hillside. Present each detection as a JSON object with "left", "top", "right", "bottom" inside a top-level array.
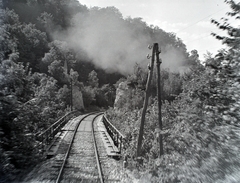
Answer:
[{"left": 55, "top": 7, "right": 188, "bottom": 75}]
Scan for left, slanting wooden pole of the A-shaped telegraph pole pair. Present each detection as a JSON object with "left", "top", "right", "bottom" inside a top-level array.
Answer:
[{"left": 137, "top": 43, "right": 157, "bottom": 157}]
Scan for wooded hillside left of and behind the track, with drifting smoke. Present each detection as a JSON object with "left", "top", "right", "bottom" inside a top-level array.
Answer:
[{"left": 0, "top": 0, "right": 188, "bottom": 182}]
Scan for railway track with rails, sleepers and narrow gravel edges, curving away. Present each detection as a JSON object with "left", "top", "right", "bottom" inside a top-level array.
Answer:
[{"left": 41, "top": 113, "right": 121, "bottom": 183}]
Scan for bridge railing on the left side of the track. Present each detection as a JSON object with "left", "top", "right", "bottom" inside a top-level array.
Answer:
[{"left": 36, "top": 111, "right": 80, "bottom": 150}]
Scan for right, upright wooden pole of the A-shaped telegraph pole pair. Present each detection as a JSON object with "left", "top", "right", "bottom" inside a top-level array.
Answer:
[{"left": 156, "top": 44, "right": 163, "bottom": 156}]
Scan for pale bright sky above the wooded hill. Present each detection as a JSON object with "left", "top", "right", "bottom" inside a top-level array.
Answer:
[{"left": 79, "top": 0, "right": 239, "bottom": 59}]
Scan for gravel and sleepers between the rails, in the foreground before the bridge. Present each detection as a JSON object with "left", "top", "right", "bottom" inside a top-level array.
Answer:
[{"left": 62, "top": 131, "right": 98, "bottom": 182}]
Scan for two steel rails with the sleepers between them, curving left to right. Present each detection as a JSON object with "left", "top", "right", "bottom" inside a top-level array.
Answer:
[{"left": 52, "top": 113, "right": 104, "bottom": 183}]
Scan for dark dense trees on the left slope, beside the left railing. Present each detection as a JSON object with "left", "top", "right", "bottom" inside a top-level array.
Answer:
[{"left": 0, "top": 1, "right": 119, "bottom": 182}]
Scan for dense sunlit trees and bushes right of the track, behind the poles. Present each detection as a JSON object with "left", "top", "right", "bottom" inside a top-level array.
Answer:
[{"left": 108, "top": 1, "right": 240, "bottom": 183}]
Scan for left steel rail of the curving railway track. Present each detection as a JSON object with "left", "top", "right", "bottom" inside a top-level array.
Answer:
[{"left": 56, "top": 112, "right": 98, "bottom": 183}]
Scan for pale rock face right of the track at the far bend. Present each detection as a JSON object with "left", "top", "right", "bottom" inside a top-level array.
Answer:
[{"left": 114, "top": 82, "right": 129, "bottom": 109}]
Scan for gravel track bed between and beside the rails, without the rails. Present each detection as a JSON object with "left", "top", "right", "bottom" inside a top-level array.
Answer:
[{"left": 20, "top": 115, "right": 131, "bottom": 183}]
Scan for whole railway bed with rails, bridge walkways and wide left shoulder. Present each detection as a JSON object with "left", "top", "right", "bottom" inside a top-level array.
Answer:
[{"left": 22, "top": 113, "right": 124, "bottom": 183}]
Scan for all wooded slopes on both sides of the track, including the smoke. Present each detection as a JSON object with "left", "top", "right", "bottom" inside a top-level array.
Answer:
[{"left": 0, "top": 0, "right": 240, "bottom": 182}]
